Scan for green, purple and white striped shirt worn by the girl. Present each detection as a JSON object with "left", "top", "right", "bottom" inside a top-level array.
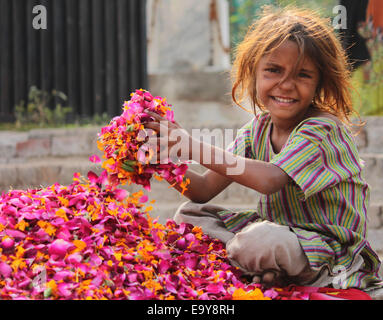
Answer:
[{"left": 220, "top": 112, "right": 381, "bottom": 289}]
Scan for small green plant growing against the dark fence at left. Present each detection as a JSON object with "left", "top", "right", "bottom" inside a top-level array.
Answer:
[{"left": 14, "top": 86, "right": 72, "bottom": 128}]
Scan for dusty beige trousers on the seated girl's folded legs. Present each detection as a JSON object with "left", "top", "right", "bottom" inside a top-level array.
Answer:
[{"left": 174, "top": 201, "right": 340, "bottom": 286}]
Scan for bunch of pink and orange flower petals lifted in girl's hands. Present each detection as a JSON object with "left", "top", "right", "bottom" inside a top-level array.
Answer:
[{"left": 97, "top": 89, "right": 190, "bottom": 190}]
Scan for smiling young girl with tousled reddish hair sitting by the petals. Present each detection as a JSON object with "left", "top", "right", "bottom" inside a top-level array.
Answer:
[{"left": 146, "top": 8, "right": 381, "bottom": 290}]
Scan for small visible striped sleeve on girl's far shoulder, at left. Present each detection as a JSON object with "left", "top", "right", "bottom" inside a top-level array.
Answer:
[{"left": 226, "top": 118, "right": 256, "bottom": 158}]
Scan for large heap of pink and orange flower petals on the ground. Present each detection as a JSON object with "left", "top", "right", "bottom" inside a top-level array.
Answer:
[{"left": 0, "top": 173, "right": 275, "bottom": 300}]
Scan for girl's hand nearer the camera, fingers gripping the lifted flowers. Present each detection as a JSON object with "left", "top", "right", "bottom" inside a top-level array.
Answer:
[{"left": 144, "top": 110, "right": 191, "bottom": 163}]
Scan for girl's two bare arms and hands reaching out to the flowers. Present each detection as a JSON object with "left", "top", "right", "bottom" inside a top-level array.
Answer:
[{"left": 145, "top": 111, "right": 290, "bottom": 196}]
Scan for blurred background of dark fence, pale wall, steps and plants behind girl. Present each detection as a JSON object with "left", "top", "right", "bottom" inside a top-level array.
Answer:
[{"left": 0, "top": 0, "right": 383, "bottom": 272}]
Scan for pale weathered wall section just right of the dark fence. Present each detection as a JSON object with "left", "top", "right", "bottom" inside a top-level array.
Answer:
[{"left": 147, "top": 0, "right": 230, "bottom": 74}]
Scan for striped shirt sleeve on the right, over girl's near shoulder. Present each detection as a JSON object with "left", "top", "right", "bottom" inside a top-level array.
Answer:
[{"left": 271, "top": 119, "right": 361, "bottom": 199}]
